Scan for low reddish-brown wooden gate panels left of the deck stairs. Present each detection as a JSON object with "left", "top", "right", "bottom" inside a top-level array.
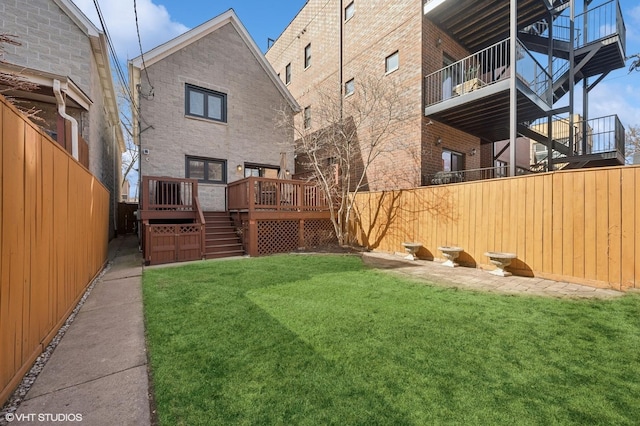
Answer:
[{"left": 145, "top": 223, "right": 204, "bottom": 265}]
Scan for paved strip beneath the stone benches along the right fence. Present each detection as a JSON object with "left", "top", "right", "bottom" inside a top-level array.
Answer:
[{"left": 362, "top": 252, "right": 624, "bottom": 299}]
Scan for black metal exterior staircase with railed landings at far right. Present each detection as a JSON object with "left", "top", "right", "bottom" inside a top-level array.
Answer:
[{"left": 518, "top": 1, "right": 625, "bottom": 168}]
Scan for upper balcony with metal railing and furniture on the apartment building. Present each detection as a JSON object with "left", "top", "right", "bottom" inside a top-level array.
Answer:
[{"left": 424, "top": 38, "right": 552, "bottom": 141}]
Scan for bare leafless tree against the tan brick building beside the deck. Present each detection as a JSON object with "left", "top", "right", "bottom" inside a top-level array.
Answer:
[{"left": 279, "top": 73, "right": 419, "bottom": 245}]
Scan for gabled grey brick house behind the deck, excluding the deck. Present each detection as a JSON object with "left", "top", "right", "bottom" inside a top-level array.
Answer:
[{"left": 129, "top": 10, "right": 299, "bottom": 211}]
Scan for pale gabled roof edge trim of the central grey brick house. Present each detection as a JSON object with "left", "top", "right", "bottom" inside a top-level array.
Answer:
[{"left": 129, "top": 9, "right": 300, "bottom": 112}]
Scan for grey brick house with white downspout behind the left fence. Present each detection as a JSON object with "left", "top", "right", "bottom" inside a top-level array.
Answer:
[{"left": 0, "top": 0, "right": 125, "bottom": 236}]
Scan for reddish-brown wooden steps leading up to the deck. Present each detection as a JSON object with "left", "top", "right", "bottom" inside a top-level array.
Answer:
[{"left": 204, "top": 212, "right": 244, "bottom": 259}]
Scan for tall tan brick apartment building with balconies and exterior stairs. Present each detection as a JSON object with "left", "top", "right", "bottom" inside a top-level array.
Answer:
[{"left": 266, "top": 0, "right": 625, "bottom": 190}]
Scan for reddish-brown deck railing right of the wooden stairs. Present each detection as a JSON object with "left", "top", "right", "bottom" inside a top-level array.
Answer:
[{"left": 227, "top": 177, "right": 329, "bottom": 211}]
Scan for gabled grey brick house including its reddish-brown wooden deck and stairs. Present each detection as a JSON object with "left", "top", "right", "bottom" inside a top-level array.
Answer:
[{"left": 129, "top": 10, "right": 330, "bottom": 264}]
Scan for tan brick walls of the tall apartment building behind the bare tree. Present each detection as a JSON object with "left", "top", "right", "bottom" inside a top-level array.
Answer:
[{"left": 266, "top": 0, "right": 480, "bottom": 190}]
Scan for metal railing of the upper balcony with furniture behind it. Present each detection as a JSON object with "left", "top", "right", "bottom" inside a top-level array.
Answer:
[{"left": 424, "top": 38, "right": 551, "bottom": 107}]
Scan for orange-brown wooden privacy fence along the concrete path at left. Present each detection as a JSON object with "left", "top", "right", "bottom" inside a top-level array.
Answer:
[{"left": 0, "top": 96, "right": 109, "bottom": 405}]
